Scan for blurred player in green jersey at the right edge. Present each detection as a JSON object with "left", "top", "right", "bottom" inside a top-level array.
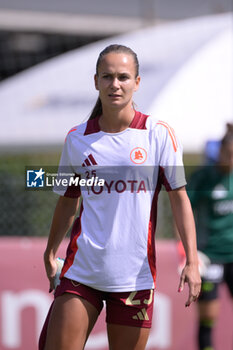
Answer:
[{"left": 188, "top": 124, "right": 233, "bottom": 350}]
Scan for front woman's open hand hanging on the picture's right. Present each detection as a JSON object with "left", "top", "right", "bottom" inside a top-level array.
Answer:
[{"left": 178, "top": 264, "right": 201, "bottom": 307}]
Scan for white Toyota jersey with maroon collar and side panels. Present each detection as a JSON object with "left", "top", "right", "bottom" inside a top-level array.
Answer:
[{"left": 54, "top": 112, "right": 186, "bottom": 292}]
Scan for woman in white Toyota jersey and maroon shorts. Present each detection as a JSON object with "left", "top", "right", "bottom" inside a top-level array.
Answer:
[{"left": 40, "top": 45, "right": 201, "bottom": 350}]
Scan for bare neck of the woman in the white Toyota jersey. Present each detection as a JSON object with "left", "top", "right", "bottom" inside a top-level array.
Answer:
[{"left": 99, "top": 106, "right": 135, "bottom": 133}]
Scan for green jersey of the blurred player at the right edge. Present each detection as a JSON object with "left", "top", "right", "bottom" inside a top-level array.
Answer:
[{"left": 187, "top": 165, "right": 233, "bottom": 263}]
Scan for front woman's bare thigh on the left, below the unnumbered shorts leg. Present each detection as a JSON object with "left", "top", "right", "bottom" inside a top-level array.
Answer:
[{"left": 44, "top": 293, "right": 99, "bottom": 350}]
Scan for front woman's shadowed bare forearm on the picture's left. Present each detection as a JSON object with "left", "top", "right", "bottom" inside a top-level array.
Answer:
[{"left": 44, "top": 197, "right": 78, "bottom": 260}]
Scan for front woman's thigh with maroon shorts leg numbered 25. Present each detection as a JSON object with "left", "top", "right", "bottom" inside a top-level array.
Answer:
[{"left": 106, "top": 290, "right": 154, "bottom": 350}]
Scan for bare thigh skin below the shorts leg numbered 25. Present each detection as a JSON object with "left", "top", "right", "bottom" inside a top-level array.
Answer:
[{"left": 107, "top": 324, "right": 150, "bottom": 350}]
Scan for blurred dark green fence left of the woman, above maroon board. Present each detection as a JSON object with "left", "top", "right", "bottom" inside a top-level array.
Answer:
[{"left": 0, "top": 153, "right": 58, "bottom": 236}]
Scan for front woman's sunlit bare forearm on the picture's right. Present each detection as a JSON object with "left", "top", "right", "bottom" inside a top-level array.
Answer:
[{"left": 169, "top": 188, "right": 198, "bottom": 265}]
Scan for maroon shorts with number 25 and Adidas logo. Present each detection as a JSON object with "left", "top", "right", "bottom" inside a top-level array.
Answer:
[{"left": 55, "top": 278, "right": 154, "bottom": 328}]
